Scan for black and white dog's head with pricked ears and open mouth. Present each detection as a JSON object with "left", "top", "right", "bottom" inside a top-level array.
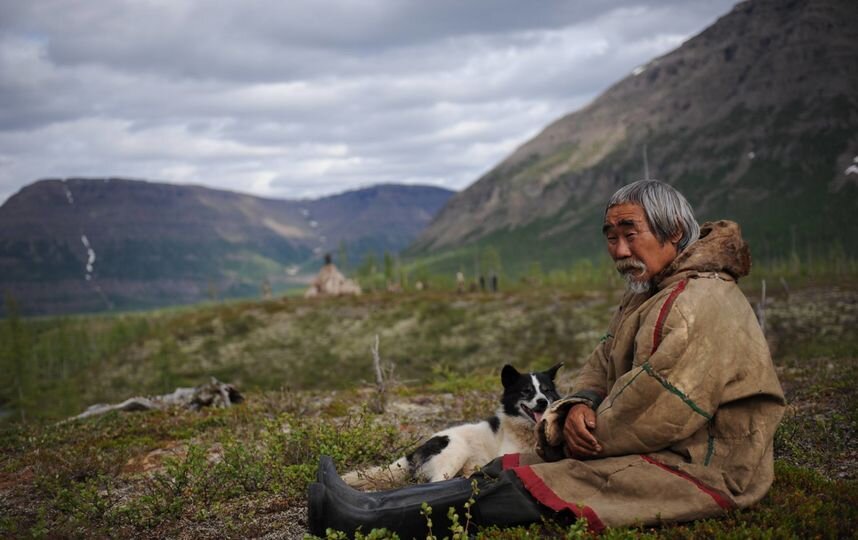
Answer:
[{"left": 494, "top": 362, "right": 563, "bottom": 424}]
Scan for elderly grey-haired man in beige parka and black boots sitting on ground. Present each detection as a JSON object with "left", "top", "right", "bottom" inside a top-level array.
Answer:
[{"left": 309, "top": 180, "right": 785, "bottom": 538}]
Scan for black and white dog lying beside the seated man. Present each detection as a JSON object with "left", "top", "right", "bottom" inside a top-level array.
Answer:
[{"left": 343, "top": 362, "right": 563, "bottom": 489}]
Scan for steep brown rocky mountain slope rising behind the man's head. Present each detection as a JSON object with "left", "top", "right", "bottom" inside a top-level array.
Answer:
[{"left": 406, "top": 0, "right": 858, "bottom": 269}]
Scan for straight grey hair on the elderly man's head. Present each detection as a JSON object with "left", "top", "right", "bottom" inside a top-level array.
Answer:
[{"left": 605, "top": 180, "right": 700, "bottom": 251}]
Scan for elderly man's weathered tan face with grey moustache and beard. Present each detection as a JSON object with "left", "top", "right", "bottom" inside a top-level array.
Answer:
[{"left": 602, "top": 203, "right": 681, "bottom": 292}]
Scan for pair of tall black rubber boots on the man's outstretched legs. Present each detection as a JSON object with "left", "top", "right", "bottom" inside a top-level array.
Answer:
[{"left": 308, "top": 459, "right": 550, "bottom": 539}]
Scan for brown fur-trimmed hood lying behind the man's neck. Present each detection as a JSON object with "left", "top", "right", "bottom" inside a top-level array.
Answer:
[{"left": 654, "top": 220, "right": 751, "bottom": 288}]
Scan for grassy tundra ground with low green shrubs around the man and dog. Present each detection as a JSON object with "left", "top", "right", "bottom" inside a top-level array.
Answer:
[{"left": 0, "top": 268, "right": 858, "bottom": 538}]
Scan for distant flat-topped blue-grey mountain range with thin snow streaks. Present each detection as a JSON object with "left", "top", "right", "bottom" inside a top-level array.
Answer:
[{"left": 0, "top": 178, "right": 452, "bottom": 314}]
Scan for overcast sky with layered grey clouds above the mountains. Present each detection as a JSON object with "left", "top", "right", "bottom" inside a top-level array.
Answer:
[{"left": 0, "top": 0, "right": 733, "bottom": 202}]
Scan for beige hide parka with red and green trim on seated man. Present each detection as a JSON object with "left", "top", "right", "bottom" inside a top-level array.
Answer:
[{"left": 502, "top": 221, "right": 785, "bottom": 531}]
